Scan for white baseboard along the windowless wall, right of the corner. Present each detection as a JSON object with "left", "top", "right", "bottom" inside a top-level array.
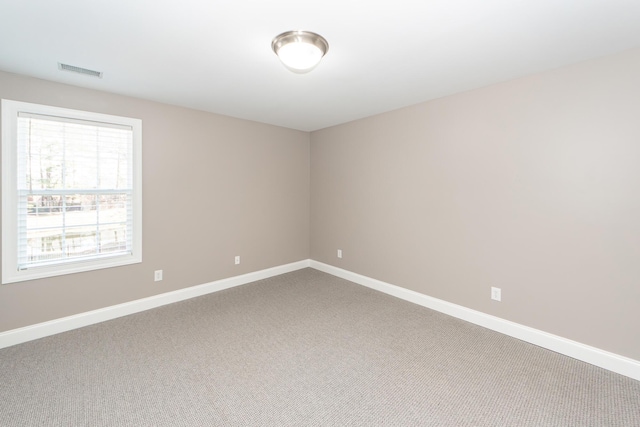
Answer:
[{"left": 311, "top": 260, "right": 640, "bottom": 381}]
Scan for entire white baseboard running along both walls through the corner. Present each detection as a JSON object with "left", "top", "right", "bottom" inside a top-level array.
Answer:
[{"left": 0, "top": 259, "right": 640, "bottom": 381}]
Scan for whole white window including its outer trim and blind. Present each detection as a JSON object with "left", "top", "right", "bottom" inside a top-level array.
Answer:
[{"left": 2, "top": 99, "right": 142, "bottom": 283}]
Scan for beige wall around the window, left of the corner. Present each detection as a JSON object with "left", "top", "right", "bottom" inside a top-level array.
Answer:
[{"left": 0, "top": 72, "right": 309, "bottom": 332}]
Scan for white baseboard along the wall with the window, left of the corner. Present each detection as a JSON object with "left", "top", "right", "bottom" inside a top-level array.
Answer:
[{"left": 0, "top": 259, "right": 310, "bottom": 348}]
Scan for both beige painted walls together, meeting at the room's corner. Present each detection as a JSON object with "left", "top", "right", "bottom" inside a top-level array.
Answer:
[{"left": 5, "top": 50, "right": 640, "bottom": 360}]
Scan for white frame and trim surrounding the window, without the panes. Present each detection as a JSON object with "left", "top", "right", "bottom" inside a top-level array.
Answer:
[{"left": 1, "top": 99, "right": 142, "bottom": 284}]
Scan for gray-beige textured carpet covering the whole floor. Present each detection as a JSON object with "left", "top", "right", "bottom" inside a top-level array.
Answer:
[{"left": 0, "top": 269, "right": 640, "bottom": 427}]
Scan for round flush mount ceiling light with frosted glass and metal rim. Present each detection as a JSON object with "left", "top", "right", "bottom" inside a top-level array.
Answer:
[{"left": 271, "top": 31, "right": 329, "bottom": 74}]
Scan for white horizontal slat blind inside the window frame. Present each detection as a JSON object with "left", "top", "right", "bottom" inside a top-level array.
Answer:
[{"left": 17, "top": 113, "right": 133, "bottom": 270}]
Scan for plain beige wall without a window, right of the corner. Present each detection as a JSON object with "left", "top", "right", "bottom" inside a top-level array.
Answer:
[{"left": 311, "top": 50, "right": 640, "bottom": 360}]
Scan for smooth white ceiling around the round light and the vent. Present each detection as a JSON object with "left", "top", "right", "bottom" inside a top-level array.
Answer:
[{"left": 0, "top": 0, "right": 640, "bottom": 131}]
